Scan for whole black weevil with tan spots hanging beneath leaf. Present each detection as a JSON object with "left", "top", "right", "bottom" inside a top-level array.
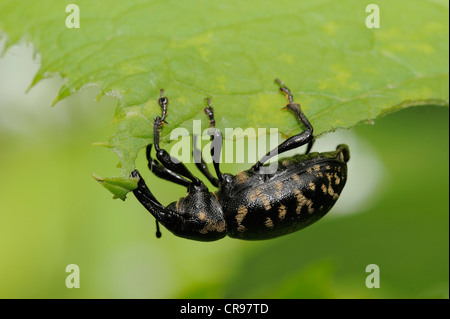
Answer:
[{"left": 131, "top": 80, "right": 350, "bottom": 241}]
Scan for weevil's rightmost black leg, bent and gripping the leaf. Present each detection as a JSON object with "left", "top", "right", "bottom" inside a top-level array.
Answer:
[{"left": 251, "top": 79, "right": 314, "bottom": 171}]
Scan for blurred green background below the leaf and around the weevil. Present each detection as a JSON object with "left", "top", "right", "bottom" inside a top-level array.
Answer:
[{"left": 0, "top": 41, "right": 449, "bottom": 298}]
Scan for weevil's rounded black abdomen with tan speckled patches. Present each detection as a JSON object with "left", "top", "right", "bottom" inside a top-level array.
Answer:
[{"left": 219, "top": 152, "right": 347, "bottom": 240}]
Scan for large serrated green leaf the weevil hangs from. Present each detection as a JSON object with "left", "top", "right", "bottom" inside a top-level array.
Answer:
[{"left": 0, "top": 0, "right": 449, "bottom": 200}]
